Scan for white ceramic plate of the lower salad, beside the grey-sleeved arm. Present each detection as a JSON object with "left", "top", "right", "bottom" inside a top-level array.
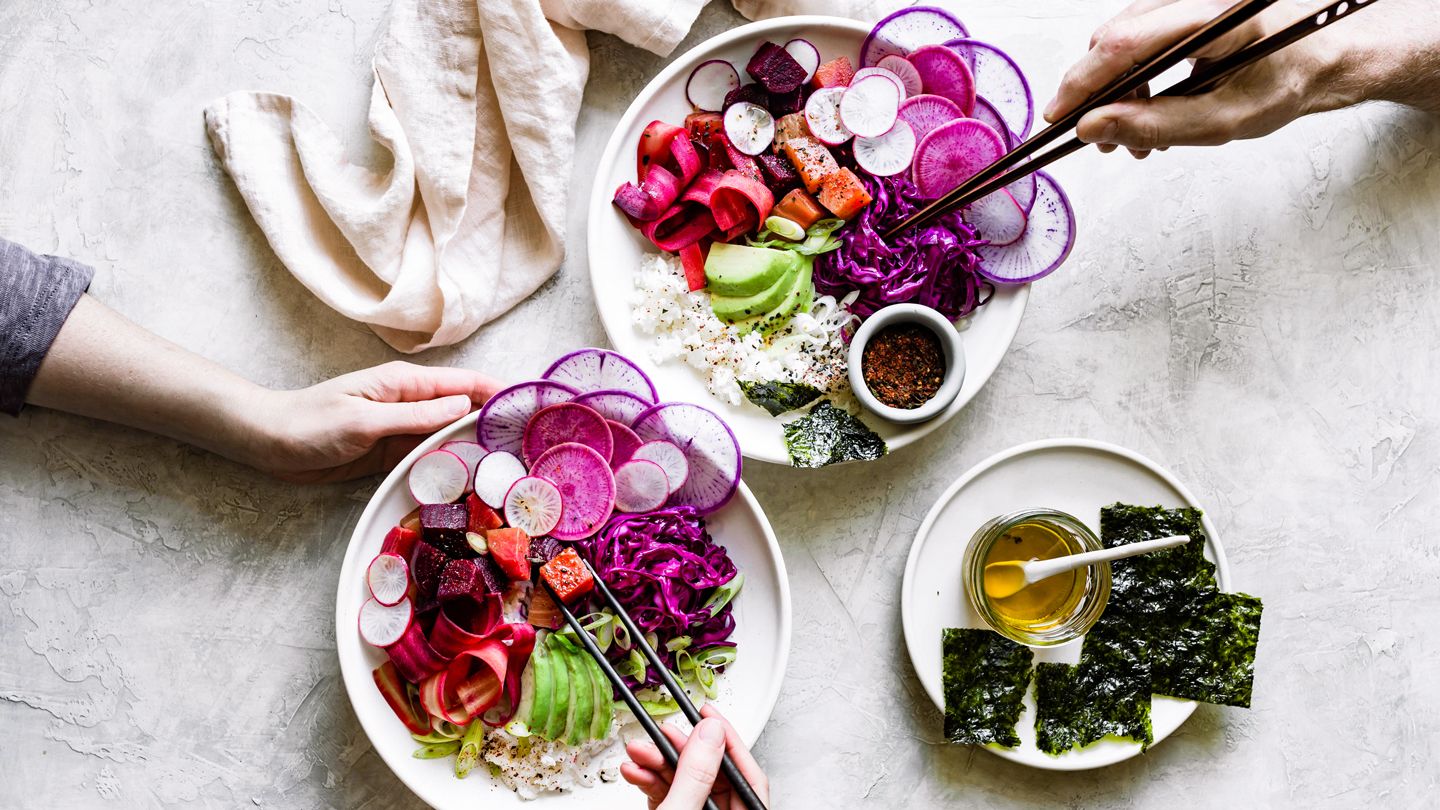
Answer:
[{"left": 336, "top": 414, "right": 791, "bottom": 810}]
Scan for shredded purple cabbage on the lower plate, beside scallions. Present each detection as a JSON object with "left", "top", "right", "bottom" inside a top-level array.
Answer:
[{"left": 576, "top": 506, "right": 736, "bottom": 689}]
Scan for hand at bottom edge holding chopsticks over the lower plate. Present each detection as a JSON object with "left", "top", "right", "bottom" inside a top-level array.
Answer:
[{"left": 621, "top": 705, "right": 770, "bottom": 810}]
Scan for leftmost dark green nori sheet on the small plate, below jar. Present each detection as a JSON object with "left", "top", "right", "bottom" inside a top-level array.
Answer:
[{"left": 940, "top": 627, "right": 1035, "bottom": 748}]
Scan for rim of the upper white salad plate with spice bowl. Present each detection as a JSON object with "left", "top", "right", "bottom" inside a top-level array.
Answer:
[{"left": 585, "top": 14, "right": 1030, "bottom": 467}]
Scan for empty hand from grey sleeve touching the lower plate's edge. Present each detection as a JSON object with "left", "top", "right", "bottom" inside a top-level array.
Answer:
[{"left": 233, "top": 362, "right": 500, "bottom": 483}]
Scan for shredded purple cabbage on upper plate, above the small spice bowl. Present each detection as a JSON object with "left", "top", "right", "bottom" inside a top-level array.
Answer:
[{"left": 815, "top": 172, "right": 995, "bottom": 320}]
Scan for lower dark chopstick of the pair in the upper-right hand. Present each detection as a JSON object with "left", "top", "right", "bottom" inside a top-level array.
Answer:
[{"left": 887, "top": 0, "right": 1380, "bottom": 221}]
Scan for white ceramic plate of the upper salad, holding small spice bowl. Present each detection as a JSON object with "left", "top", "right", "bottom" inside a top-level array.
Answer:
[{"left": 589, "top": 16, "right": 1030, "bottom": 464}]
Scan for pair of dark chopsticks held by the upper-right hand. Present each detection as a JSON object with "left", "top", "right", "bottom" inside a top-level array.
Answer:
[{"left": 884, "top": 0, "right": 1380, "bottom": 239}]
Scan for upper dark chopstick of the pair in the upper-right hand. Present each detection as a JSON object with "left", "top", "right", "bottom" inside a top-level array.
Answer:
[{"left": 884, "top": 0, "right": 1278, "bottom": 239}]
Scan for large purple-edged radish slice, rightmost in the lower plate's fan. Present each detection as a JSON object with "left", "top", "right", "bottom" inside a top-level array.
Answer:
[{"left": 634, "top": 402, "right": 742, "bottom": 512}]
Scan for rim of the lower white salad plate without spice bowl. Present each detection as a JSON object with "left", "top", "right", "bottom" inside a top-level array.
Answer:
[{"left": 336, "top": 411, "right": 792, "bottom": 807}]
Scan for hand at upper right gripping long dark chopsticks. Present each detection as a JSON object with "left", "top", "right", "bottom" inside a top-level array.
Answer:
[{"left": 1044, "top": 0, "right": 1365, "bottom": 159}]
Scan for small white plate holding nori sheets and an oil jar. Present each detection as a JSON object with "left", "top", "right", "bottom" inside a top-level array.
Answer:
[{"left": 900, "top": 438, "right": 1230, "bottom": 771}]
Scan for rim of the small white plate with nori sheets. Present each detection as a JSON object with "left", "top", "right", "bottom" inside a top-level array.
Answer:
[{"left": 900, "top": 438, "right": 1230, "bottom": 771}]
